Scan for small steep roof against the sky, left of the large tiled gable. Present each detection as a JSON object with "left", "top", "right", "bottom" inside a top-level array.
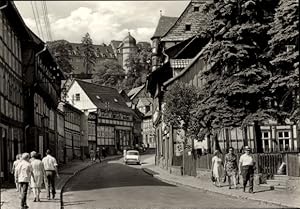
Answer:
[{"left": 151, "top": 16, "right": 178, "bottom": 40}]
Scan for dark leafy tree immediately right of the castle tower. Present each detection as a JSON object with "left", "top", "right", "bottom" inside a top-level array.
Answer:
[{"left": 124, "top": 47, "right": 151, "bottom": 89}]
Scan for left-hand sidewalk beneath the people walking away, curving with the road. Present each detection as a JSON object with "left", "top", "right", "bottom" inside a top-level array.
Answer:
[{"left": 0, "top": 155, "right": 120, "bottom": 209}]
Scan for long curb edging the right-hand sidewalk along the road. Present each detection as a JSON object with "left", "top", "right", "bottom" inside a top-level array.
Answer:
[{"left": 143, "top": 168, "right": 299, "bottom": 208}]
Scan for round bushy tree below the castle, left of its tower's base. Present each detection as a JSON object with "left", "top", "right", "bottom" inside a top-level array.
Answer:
[{"left": 92, "top": 59, "right": 125, "bottom": 89}]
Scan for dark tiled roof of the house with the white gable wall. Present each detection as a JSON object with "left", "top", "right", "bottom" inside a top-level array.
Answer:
[{"left": 75, "top": 79, "right": 134, "bottom": 114}]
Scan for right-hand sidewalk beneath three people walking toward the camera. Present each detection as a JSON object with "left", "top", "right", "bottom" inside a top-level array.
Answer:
[{"left": 143, "top": 157, "right": 300, "bottom": 208}]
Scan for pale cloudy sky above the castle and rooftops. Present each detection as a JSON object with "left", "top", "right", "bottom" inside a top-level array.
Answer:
[{"left": 15, "top": 1, "right": 189, "bottom": 44}]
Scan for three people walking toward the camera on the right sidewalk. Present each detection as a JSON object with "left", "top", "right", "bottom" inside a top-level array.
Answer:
[{"left": 211, "top": 146, "right": 255, "bottom": 193}]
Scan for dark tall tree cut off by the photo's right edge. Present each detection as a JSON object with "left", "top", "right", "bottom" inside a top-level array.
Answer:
[{"left": 268, "top": 0, "right": 300, "bottom": 122}]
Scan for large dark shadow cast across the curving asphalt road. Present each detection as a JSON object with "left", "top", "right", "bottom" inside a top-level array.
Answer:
[{"left": 65, "top": 162, "right": 176, "bottom": 192}]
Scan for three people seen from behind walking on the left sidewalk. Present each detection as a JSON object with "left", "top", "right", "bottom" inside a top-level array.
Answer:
[{"left": 12, "top": 149, "right": 59, "bottom": 209}]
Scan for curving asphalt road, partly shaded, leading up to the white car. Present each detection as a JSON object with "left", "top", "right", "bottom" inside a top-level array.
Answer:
[{"left": 64, "top": 155, "right": 278, "bottom": 209}]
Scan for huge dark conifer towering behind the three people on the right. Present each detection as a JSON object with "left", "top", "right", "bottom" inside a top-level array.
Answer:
[{"left": 194, "top": 0, "right": 276, "bottom": 152}]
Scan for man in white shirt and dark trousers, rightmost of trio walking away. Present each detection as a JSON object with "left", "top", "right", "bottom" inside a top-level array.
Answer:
[{"left": 42, "top": 149, "right": 59, "bottom": 200}]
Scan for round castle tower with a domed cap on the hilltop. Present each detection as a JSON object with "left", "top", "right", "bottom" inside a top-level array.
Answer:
[{"left": 121, "top": 32, "right": 137, "bottom": 74}]
